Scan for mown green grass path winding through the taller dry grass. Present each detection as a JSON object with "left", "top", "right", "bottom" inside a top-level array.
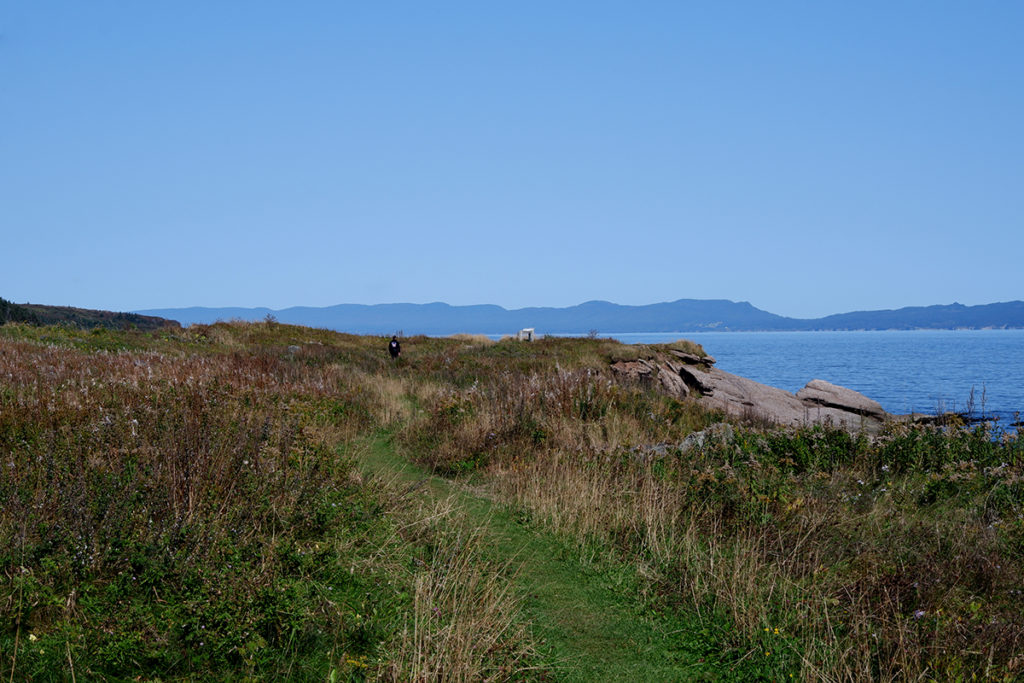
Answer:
[{"left": 360, "top": 436, "right": 721, "bottom": 681}]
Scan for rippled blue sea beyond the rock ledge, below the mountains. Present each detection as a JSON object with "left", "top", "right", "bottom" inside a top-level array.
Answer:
[{"left": 532, "top": 330, "right": 1024, "bottom": 428}]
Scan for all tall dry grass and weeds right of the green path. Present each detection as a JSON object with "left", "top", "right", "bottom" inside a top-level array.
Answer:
[{"left": 402, "top": 350, "right": 1024, "bottom": 681}]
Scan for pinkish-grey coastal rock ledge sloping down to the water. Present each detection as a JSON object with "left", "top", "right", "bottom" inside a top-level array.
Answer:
[{"left": 611, "top": 350, "right": 890, "bottom": 433}]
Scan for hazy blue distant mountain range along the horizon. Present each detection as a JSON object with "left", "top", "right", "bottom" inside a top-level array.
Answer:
[{"left": 134, "top": 299, "right": 1024, "bottom": 335}]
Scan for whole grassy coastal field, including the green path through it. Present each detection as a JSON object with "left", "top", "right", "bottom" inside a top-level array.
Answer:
[{"left": 0, "top": 321, "right": 1024, "bottom": 681}]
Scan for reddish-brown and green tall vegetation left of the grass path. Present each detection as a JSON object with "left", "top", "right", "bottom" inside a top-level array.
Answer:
[{"left": 0, "top": 324, "right": 544, "bottom": 680}]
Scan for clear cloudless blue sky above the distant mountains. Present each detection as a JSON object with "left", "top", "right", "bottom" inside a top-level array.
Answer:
[{"left": 0, "top": 0, "right": 1024, "bottom": 316}]
